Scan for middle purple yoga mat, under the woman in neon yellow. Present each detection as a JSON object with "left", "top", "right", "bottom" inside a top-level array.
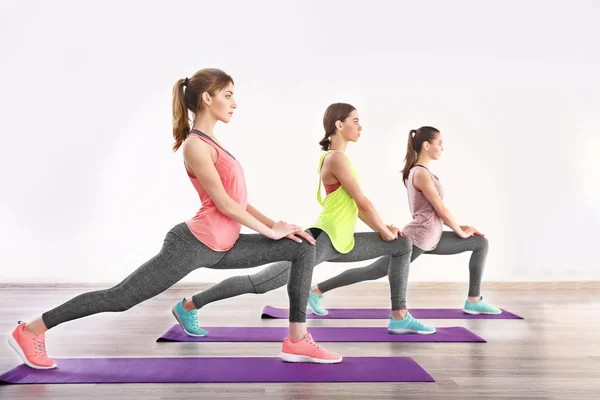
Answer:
[{"left": 156, "top": 325, "right": 486, "bottom": 343}]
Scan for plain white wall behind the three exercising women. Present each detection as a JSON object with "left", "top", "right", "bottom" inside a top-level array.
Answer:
[{"left": 0, "top": 0, "right": 600, "bottom": 283}]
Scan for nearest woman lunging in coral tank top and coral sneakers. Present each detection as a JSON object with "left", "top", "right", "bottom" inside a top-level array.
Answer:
[{"left": 9, "top": 69, "right": 342, "bottom": 369}]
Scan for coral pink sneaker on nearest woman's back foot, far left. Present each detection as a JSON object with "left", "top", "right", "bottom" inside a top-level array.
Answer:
[{"left": 8, "top": 321, "right": 56, "bottom": 369}]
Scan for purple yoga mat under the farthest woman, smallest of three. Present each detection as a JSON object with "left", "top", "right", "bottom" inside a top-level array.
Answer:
[{"left": 260, "top": 306, "right": 523, "bottom": 319}]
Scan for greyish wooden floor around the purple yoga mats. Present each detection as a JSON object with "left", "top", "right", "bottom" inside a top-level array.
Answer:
[{"left": 0, "top": 282, "right": 600, "bottom": 400}]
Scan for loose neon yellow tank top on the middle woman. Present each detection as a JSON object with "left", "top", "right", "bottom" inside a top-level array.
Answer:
[{"left": 312, "top": 150, "right": 358, "bottom": 254}]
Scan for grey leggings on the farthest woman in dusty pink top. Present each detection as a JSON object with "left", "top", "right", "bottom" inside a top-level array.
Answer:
[{"left": 317, "top": 231, "right": 488, "bottom": 297}]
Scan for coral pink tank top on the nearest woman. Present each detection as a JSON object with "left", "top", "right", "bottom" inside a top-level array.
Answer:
[{"left": 185, "top": 130, "right": 248, "bottom": 251}]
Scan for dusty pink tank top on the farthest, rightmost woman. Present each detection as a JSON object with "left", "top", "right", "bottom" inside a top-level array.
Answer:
[{"left": 402, "top": 165, "right": 444, "bottom": 251}]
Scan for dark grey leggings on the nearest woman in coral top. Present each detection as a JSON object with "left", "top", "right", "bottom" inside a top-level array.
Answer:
[{"left": 42, "top": 223, "right": 315, "bottom": 328}]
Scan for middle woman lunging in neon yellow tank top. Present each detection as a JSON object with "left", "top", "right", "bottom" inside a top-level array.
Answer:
[{"left": 188, "top": 103, "right": 435, "bottom": 344}]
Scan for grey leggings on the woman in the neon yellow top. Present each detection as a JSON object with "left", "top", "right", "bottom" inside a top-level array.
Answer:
[{"left": 195, "top": 229, "right": 412, "bottom": 310}]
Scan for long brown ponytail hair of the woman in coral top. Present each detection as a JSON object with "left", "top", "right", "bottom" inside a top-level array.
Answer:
[{"left": 173, "top": 68, "right": 233, "bottom": 151}]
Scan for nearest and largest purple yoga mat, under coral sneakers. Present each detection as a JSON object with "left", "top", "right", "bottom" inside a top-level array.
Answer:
[{"left": 0, "top": 357, "right": 435, "bottom": 384}]
